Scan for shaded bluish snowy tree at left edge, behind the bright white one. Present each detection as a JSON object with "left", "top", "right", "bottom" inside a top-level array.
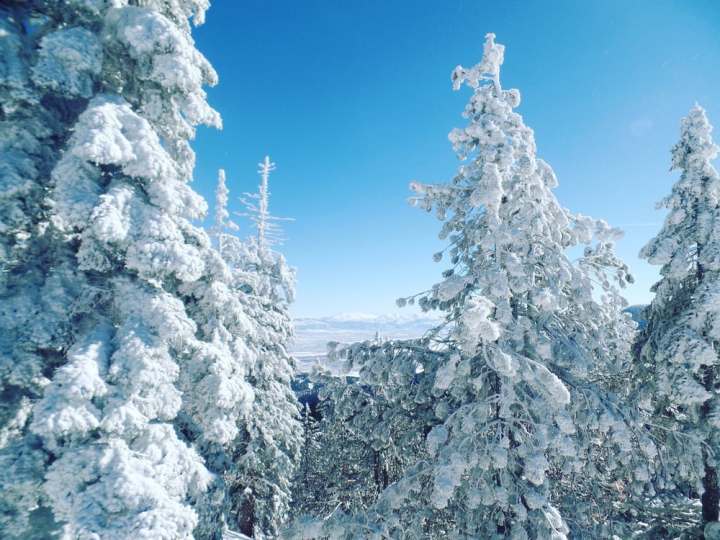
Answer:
[{"left": 0, "top": 6, "right": 87, "bottom": 538}]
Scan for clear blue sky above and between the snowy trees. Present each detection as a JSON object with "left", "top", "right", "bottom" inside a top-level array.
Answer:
[{"left": 194, "top": 0, "right": 720, "bottom": 316}]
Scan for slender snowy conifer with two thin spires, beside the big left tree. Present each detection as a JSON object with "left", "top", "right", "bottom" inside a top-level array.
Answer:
[{"left": 210, "top": 157, "right": 302, "bottom": 539}]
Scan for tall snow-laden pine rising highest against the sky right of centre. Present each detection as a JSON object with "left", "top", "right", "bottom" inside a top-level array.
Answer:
[{"left": 288, "top": 34, "right": 652, "bottom": 539}]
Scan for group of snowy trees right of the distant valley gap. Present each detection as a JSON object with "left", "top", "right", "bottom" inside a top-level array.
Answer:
[{"left": 287, "top": 34, "right": 720, "bottom": 540}]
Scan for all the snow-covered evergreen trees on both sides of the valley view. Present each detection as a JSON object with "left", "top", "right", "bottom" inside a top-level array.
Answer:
[{"left": 0, "top": 0, "right": 720, "bottom": 540}]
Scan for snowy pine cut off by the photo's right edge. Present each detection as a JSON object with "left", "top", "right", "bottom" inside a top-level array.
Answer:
[{"left": 636, "top": 106, "right": 720, "bottom": 538}]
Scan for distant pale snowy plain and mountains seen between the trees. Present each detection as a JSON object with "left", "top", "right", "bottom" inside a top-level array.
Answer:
[{"left": 291, "top": 313, "right": 439, "bottom": 372}]
